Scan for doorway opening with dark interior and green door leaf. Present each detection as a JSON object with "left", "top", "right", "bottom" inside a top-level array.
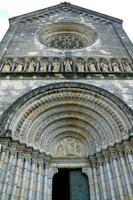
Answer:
[{"left": 52, "top": 169, "right": 90, "bottom": 200}]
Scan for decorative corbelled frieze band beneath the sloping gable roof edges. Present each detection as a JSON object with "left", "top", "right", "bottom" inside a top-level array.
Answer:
[{"left": 16, "top": 2, "right": 122, "bottom": 26}]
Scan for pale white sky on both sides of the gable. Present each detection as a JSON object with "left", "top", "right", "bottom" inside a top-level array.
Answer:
[{"left": 0, "top": 0, "right": 133, "bottom": 42}]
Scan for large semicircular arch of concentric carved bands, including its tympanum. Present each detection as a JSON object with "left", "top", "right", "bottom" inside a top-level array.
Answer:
[{"left": 0, "top": 82, "right": 133, "bottom": 157}]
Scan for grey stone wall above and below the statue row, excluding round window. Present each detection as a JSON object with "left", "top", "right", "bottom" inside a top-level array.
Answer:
[{"left": 0, "top": 3, "right": 133, "bottom": 119}]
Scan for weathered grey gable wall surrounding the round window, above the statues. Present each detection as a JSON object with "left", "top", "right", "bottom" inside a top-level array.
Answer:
[{"left": 0, "top": 3, "right": 133, "bottom": 58}]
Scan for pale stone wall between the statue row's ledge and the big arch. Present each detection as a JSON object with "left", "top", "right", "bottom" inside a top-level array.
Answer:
[{"left": 0, "top": 79, "right": 133, "bottom": 116}]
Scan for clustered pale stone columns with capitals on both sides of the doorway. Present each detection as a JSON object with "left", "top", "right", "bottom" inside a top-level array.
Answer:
[{"left": 0, "top": 137, "right": 133, "bottom": 199}]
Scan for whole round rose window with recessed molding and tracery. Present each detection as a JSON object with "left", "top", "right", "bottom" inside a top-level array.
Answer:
[{"left": 38, "top": 22, "right": 98, "bottom": 50}]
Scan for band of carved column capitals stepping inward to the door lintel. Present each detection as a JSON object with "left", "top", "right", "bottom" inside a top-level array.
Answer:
[{"left": 0, "top": 136, "right": 133, "bottom": 164}]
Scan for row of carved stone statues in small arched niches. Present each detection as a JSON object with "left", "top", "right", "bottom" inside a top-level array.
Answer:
[{"left": 0, "top": 57, "right": 133, "bottom": 74}]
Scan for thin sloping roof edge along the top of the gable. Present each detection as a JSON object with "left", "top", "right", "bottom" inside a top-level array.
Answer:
[{"left": 9, "top": 2, "right": 123, "bottom": 24}]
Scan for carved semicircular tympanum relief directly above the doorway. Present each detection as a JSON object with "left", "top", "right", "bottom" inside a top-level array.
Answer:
[{"left": 54, "top": 136, "right": 84, "bottom": 157}]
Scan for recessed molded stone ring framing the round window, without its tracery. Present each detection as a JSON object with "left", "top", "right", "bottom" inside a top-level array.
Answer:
[{"left": 37, "top": 22, "right": 98, "bottom": 51}]
